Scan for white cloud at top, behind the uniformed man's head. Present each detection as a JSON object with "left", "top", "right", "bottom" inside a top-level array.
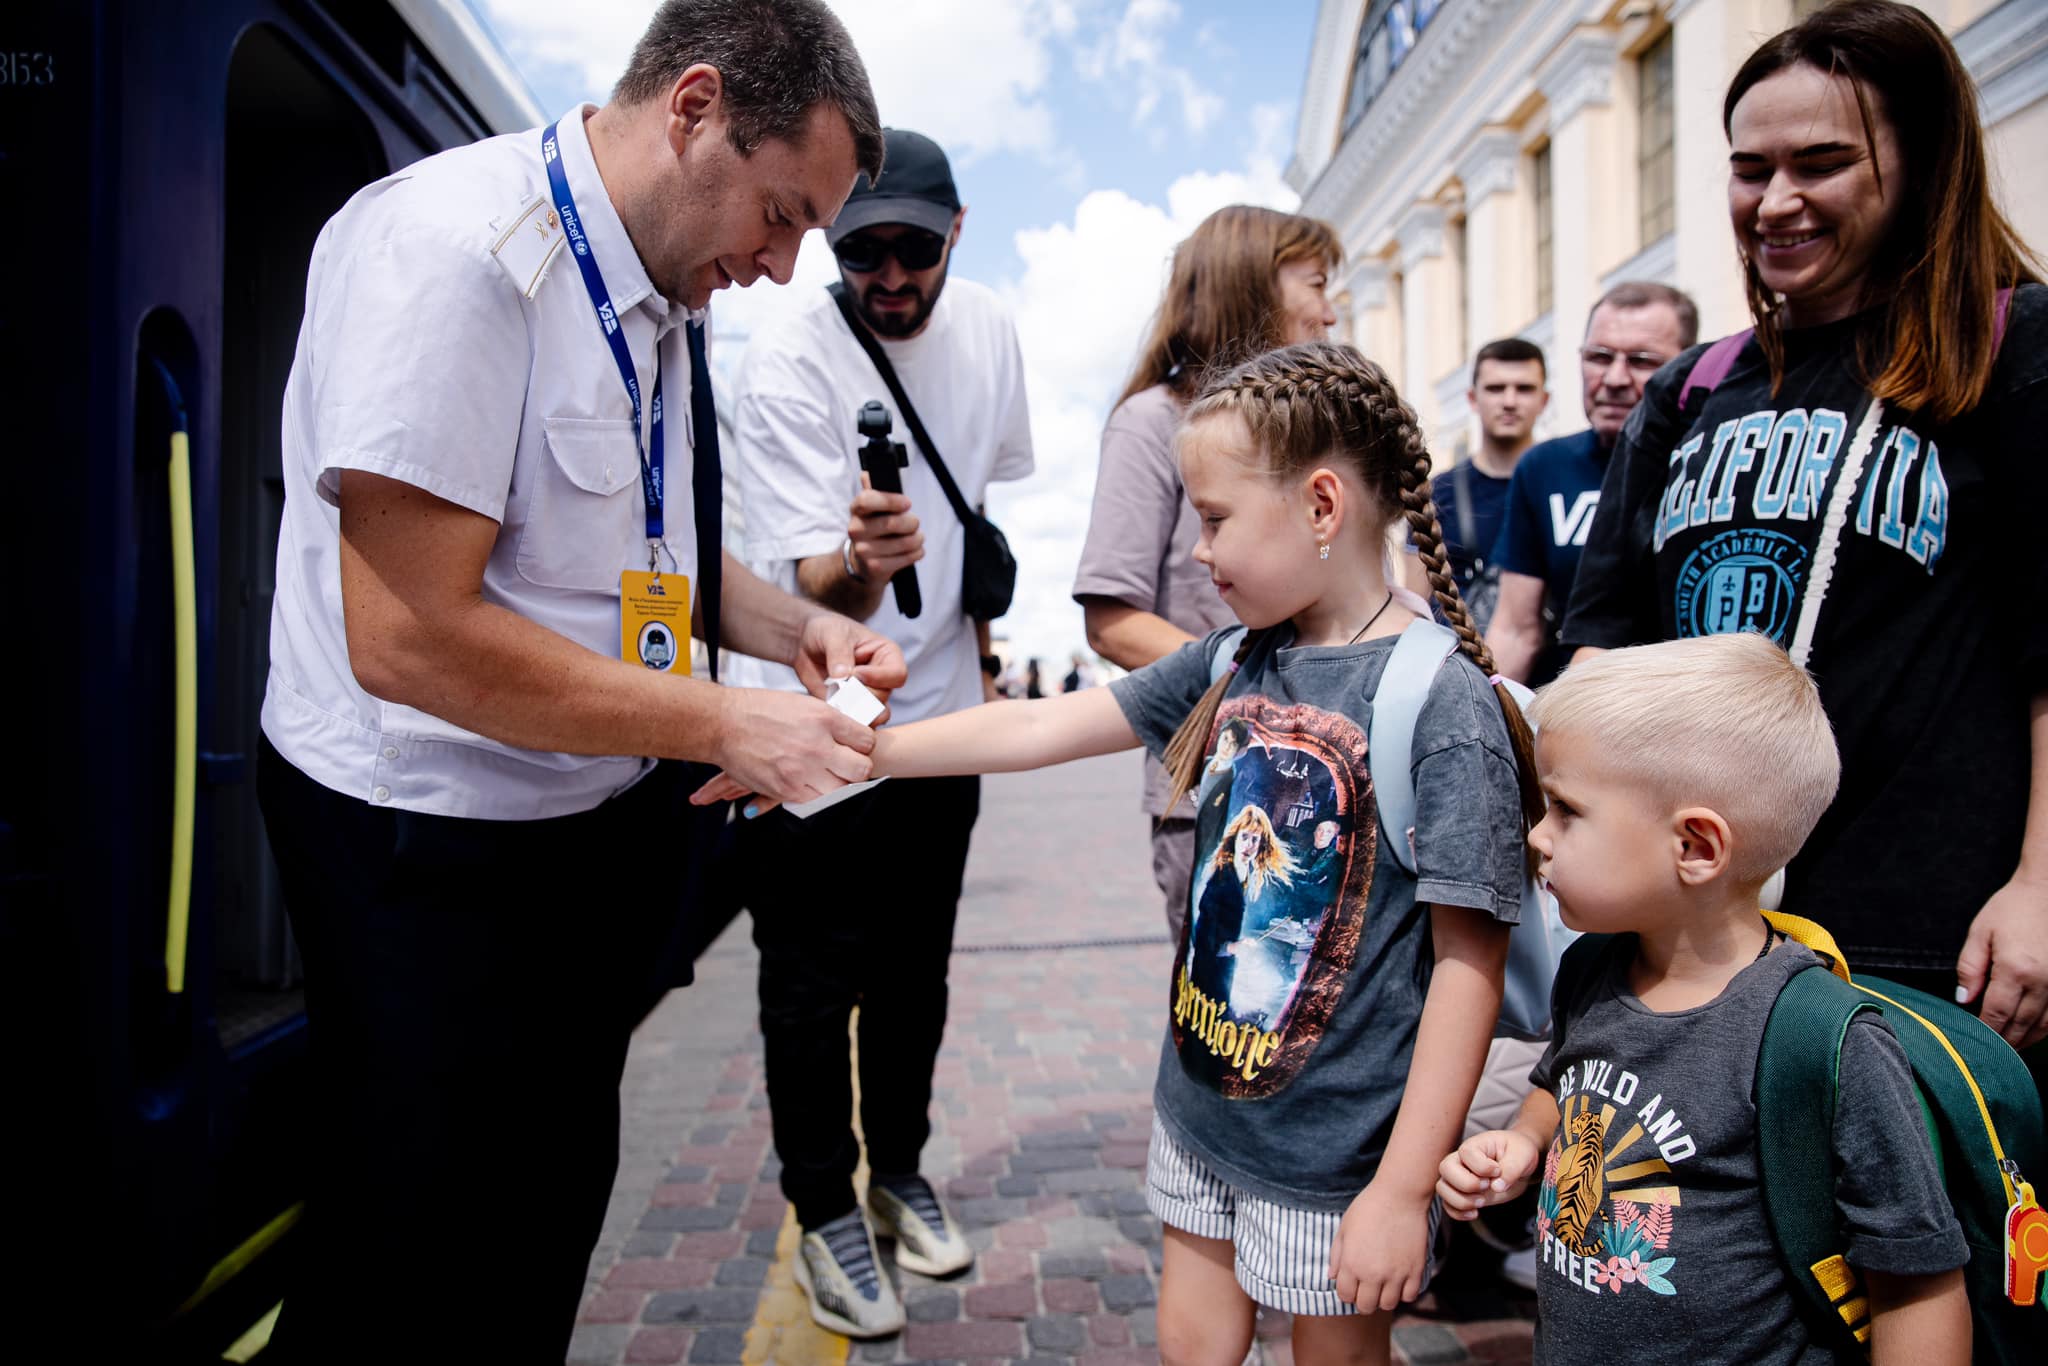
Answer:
[{"left": 481, "top": 0, "right": 1079, "bottom": 162}]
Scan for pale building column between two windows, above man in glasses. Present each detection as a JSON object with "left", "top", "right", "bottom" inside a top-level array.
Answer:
[{"left": 1536, "top": 29, "right": 1636, "bottom": 358}]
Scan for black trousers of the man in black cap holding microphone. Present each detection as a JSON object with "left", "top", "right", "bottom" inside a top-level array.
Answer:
[{"left": 737, "top": 778, "right": 981, "bottom": 1229}]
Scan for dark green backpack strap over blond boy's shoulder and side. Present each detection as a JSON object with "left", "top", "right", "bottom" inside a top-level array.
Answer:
[{"left": 1755, "top": 967, "right": 1882, "bottom": 1346}]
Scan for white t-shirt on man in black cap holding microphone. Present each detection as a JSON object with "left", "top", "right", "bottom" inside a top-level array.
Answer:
[{"left": 727, "top": 279, "right": 1032, "bottom": 721}]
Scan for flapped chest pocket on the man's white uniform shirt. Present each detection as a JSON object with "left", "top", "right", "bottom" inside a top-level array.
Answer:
[{"left": 518, "top": 418, "right": 647, "bottom": 592}]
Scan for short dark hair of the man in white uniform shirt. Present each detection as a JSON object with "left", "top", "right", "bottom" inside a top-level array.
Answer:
[{"left": 612, "top": 0, "right": 883, "bottom": 180}]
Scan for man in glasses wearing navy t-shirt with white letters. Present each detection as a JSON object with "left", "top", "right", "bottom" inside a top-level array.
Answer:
[{"left": 1490, "top": 281, "right": 1700, "bottom": 686}]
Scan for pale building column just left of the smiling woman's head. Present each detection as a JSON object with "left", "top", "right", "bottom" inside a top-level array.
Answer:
[{"left": 1665, "top": 0, "right": 1792, "bottom": 340}]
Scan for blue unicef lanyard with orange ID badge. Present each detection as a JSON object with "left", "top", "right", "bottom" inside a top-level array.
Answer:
[{"left": 541, "top": 123, "right": 690, "bottom": 674}]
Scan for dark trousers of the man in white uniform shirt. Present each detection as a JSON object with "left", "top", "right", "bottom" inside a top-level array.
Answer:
[{"left": 258, "top": 743, "right": 688, "bottom": 1366}]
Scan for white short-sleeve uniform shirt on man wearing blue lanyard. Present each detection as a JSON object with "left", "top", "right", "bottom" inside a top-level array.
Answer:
[{"left": 262, "top": 106, "right": 696, "bottom": 821}]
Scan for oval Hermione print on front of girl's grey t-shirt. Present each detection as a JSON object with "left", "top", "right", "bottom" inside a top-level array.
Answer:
[{"left": 1171, "top": 696, "right": 1378, "bottom": 1100}]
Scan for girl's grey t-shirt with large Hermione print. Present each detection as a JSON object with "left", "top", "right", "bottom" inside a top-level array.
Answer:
[{"left": 1110, "top": 627, "right": 1522, "bottom": 1210}]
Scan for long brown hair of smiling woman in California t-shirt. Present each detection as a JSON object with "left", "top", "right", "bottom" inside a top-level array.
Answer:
[{"left": 1720, "top": 0, "right": 2040, "bottom": 422}]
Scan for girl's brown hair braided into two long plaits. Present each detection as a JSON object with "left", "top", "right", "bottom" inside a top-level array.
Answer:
[{"left": 1165, "top": 342, "right": 1544, "bottom": 829}]
